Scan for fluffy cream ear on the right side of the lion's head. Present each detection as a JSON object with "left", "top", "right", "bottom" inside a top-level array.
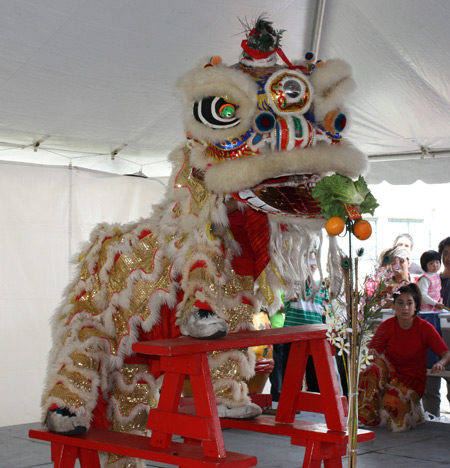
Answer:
[{"left": 309, "top": 59, "right": 356, "bottom": 122}]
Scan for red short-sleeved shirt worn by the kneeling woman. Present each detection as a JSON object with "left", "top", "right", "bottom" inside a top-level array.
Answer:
[{"left": 369, "top": 317, "right": 448, "bottom": 396}]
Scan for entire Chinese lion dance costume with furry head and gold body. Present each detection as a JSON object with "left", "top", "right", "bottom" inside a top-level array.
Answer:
[{"left": 42, "top": 18, "right": 367, "bottom": 468}]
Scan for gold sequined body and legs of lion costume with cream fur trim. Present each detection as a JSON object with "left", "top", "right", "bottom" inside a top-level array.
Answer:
[{"left": 43, "top": 150, "right": 282, "bottom": 466}]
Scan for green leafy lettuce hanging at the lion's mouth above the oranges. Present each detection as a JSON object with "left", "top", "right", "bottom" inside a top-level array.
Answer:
[{"left": 312, "top": 174, "right": 379, "bottom": 220}]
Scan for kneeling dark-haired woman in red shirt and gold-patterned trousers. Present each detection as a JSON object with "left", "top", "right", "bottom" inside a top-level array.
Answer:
[{"left": 358, "top": 283, "right": 450, "bottom": 432}]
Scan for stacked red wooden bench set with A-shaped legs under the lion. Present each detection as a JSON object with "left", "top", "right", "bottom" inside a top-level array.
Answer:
[{"left": 30, "top": 325, "right": 374, "bottom": 468}]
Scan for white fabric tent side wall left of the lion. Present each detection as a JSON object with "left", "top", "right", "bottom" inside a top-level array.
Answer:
[{"left": 0, "top": 163, "right": 167, "bottom": 427}]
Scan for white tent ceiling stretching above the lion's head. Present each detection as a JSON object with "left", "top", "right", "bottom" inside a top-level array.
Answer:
[{"left": 0, "top": 0, "right": 450, "bottom": 183}]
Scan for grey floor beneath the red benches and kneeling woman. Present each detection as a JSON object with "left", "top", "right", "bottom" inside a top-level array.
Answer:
[{"left": 0, "top": 413, "right": 450, "bottom": 468}]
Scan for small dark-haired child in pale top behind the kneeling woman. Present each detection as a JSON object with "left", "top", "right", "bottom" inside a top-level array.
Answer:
[{"left": 417, "top": 250, "right": 444, "bottom": 312}]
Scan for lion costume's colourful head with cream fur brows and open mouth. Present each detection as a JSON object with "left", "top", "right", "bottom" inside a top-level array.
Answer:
[{"left": 178, "top": 20, "right": 367, "bottom": 219}]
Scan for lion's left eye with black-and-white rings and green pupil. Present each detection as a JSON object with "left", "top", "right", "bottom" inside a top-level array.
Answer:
[{"left": 193, "top": 96, "right": 240, "bottom": 128}]
